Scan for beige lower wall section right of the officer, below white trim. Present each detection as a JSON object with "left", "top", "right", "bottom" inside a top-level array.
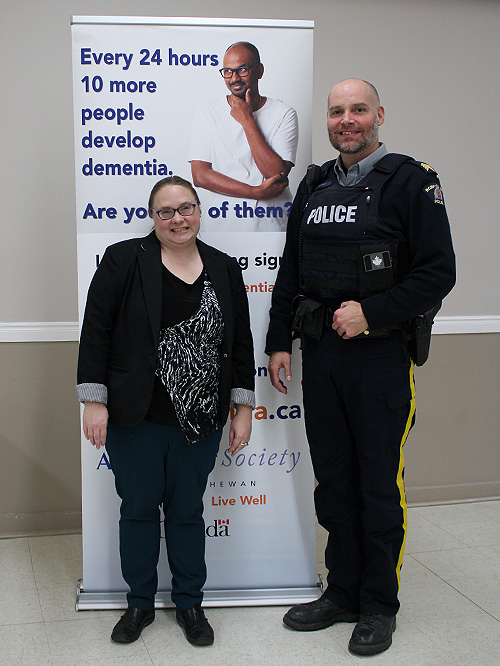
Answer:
[{"left": 405, "top": 334, "right": 500, "bottom": 503}]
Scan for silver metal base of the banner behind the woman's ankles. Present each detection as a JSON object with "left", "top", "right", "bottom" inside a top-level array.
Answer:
[{"left": 76, "top": 574, "right": 323, "bottom": 611}]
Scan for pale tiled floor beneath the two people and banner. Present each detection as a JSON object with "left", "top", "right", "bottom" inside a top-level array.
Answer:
[{"left": 0, "top": 501, "right": 500, "bottom": 666}]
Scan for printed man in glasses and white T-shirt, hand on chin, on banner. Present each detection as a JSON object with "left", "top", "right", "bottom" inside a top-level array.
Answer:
[{"left": 189, "top": 42, "right": 298, "bottom": 231}]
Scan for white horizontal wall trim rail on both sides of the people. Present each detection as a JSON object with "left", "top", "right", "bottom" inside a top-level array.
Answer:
[{"left": 0, "top": 316, "right": 500, "bottom": 343}]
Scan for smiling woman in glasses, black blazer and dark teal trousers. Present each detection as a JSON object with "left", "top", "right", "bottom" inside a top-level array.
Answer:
[{"left": 77, "top": 176, "right": 255, "bottom": 645}]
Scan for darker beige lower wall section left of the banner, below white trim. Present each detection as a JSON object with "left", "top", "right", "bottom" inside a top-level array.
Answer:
[{"left": 0, "top": 342, "right": 81, "bottom": 536}]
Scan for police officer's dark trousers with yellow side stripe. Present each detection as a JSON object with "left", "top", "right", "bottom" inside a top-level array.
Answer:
[{"left": 302, "top": 329, "right": 415, "bottom": 615}]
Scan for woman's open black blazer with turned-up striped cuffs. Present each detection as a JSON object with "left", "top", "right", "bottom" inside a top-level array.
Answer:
[{"left": 77, "top": 231, "right": 255, "bottom": 427}]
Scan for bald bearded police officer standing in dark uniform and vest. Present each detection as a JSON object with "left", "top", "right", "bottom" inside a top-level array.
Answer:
[{"left": 266, "top": 79, "right": 455, "bottom": 655}]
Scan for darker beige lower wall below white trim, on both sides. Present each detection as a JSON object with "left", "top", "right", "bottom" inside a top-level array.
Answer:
[{"left": 0, "top": 334, "right": 500, "bottom": 536}]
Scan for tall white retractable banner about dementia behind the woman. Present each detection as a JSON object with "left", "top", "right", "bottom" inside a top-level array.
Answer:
[{"left": 72, "top": 16, "right": 318, "bottom": 609}]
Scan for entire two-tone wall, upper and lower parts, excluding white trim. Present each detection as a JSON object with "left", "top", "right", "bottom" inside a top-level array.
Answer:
[{"left": 0, "top": 0, "right": 500, "bottom": 535}]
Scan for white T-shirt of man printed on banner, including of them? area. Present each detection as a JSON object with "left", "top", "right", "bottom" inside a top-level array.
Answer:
[{"left": 188, "top": 97, "right": 299, "bottom": 231}]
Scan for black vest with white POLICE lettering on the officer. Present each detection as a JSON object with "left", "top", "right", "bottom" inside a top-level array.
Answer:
[{"left": 300, "top": 153, "right": 412, "bottom": 303}]
